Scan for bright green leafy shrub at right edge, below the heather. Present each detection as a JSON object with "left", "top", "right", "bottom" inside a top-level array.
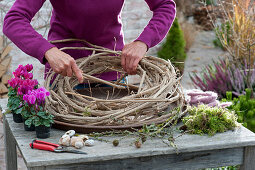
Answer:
[{"left": 222, "top": 89, "right": 255, "bottom": 132}]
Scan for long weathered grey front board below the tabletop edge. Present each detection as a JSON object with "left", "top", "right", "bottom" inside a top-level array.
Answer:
[{"left": 31, "top": 148, "right": 243, "bottom": 170}]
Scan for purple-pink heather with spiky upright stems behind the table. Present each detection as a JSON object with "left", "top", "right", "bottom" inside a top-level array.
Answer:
[{"left": 190, "top": 60, "right": 255, "bottom": 98}]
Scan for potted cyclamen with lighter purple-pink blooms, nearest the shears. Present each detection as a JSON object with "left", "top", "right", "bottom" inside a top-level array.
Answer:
[{"left": 23, "top": 87, "right": 53, "bottom": 138}]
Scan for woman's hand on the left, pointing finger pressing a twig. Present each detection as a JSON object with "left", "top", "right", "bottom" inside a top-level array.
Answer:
[{"left": 45, "top": 47, "right": 83, "bottom": 83}]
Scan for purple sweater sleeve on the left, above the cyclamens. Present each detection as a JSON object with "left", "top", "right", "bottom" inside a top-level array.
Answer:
[{"left": 3, "top": 0, "right": 54, "bottom": 64}]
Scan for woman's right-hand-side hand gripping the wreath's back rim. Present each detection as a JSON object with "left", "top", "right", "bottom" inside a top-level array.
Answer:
[{"left": 121, "top": 41, "right": 148, "bottom": 75}]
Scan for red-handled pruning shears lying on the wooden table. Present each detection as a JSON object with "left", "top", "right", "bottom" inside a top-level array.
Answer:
[{"left": 29, "top": 140, "right": 87, "bottom": 154}]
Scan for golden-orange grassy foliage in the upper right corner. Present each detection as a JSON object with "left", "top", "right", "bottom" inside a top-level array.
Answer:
[{"left": 212, "top": 0, "right": 255, "bottom": 63}]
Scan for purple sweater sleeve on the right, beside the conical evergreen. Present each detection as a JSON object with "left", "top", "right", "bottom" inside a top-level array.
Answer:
[{"left": 136, "top": 0, "right": 176, "bottom": 48}]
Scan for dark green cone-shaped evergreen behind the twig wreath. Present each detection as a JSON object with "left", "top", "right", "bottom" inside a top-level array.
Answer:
[{"left": 158, "top": 18, "right": 186, "bottom": 72}]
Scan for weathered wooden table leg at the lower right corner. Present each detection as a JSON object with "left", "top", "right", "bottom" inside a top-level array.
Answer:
[{"left": 240, "top": 146, "right": 255, "bottom": 170}]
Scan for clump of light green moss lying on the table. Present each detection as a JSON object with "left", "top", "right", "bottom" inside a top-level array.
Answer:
[{"left": 182, "top": 105, "right": 238, "bottom": 136}]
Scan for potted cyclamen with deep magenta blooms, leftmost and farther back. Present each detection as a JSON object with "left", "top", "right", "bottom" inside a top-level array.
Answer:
[{"left": 7, "top": 64, "right": 38, "bottom": 123}]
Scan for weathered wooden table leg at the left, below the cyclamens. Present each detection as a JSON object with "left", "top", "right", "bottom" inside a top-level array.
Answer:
[{"left": 4, "top": 113, "right": 17, "bottom": 170}]
